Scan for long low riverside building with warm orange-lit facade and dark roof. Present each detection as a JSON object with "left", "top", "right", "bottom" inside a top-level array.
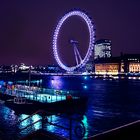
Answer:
[{"left": 95, "top": 54, "right": 140, "bottom": 75}]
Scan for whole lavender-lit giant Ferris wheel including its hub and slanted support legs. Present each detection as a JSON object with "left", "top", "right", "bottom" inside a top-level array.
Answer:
[{"left": 53, "top": 10, "right": 95, "bottom": 72}]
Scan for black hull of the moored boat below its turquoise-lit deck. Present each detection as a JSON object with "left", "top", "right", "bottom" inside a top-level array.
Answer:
[{"left": 5, "top": 99, "right": 86, "bottom": 114}]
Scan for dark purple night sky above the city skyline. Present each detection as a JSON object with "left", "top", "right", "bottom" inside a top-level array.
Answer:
[{"left": 0, "top": 0, "right": 140, "bottom": 65}]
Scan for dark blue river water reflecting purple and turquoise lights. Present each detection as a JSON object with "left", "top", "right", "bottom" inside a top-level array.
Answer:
[{"left": 0, "top": 76, "right": 140, "bottom": 140}]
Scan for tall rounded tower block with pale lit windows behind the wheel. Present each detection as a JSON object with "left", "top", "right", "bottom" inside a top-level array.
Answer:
[{"left": 94, "top": 39, "right": 112, "bottom": 59}]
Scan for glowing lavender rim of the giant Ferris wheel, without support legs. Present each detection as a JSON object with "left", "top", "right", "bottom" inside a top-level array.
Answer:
[{"left": 53, "top": 11, "right": 95, "bottom": 72}]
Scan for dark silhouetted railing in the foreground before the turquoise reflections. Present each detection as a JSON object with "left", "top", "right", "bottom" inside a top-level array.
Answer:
[{"left": 18, "top": 110, "right": 85, "bottom": 140}]
